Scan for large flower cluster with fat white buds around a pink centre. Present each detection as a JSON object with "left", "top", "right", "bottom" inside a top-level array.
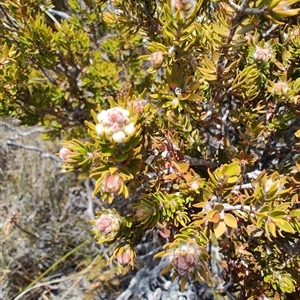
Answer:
[{"left": 96, "top": 107, "right": 135, "bottom": 143}]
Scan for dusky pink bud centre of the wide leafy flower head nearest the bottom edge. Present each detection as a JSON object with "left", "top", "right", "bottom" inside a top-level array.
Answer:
[{"left": 172, "top": 245, "right": 199, "bottom": 276}]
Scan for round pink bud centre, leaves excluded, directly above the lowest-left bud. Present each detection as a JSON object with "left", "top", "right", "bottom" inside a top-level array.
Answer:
[{"left": 95, "top": 211, "right": 121, "bottom": 239}]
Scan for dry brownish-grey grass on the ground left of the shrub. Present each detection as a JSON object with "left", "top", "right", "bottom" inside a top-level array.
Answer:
[{"left": 0, "top": 119, "right": 129, "bottom": 300}]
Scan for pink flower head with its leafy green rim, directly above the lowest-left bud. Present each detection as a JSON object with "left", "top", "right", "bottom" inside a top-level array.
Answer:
[{"left": 91, "top": 209, "right": 122, "bottom": 243}]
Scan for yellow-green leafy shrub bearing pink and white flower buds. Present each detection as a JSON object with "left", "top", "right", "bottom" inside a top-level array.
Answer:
[{"left": 0, "top": 0, "right": 300, "bottom": 300}]
